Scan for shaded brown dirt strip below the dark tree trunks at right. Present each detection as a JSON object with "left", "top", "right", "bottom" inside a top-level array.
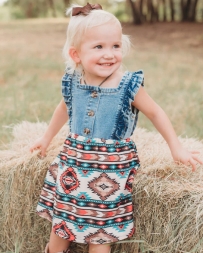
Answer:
[{"left": 124, "top": 23, "right": 203, "bottom": 49}]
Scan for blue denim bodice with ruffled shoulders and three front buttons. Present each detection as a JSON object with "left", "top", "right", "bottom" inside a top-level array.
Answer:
[{"left": 62, "top": 70, "right": 144, "bottom": 140}]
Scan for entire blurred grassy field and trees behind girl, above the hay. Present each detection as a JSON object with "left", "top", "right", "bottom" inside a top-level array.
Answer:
[{"left": 0, "top": 0, "right": 203, "bottom": 145}]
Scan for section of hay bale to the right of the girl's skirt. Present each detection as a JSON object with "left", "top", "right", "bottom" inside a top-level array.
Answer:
[{"left": 134, "top": 129, "right": 203, "bottom": 253}]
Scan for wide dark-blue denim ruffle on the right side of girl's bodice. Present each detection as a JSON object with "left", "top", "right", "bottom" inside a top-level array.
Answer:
[{"left": 112, "top": 70, "right": 144, "bottom": 139}]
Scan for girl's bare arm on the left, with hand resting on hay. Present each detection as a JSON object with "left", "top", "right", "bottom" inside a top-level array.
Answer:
[{"left": 30, "top": 99, "right": 68, "bottom": 157}]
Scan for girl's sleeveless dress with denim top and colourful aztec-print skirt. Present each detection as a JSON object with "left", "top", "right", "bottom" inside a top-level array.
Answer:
[{"left": 37, "top": 71, "right": 144, "bottom": 244}]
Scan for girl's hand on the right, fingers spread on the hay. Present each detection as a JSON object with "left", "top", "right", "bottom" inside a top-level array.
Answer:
[{"left": 172, "top": 147, "right": 203, "bottom": 171}]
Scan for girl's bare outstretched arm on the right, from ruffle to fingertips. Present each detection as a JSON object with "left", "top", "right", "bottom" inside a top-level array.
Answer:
[{"left": 132, "top": 87, "right": 203, "bottom": 171}]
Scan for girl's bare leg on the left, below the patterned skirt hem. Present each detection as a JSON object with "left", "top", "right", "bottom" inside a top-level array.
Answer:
[{"left": 49, "top": 231, "right": 70, "bottom": 253}]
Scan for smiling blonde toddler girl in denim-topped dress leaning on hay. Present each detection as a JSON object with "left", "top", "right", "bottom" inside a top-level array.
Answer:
[{"left": 31, "top": 4, "right": 201, "bottom": 253}]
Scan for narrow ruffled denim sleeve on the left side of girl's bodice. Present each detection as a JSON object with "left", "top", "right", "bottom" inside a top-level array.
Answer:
[{"left": 61, "top": 73, "right": 72, "bottom": 125}]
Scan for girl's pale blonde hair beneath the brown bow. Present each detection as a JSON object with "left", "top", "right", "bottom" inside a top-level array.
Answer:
[{"left": 63, "top": 5, "right": 131, "bottom": 74}]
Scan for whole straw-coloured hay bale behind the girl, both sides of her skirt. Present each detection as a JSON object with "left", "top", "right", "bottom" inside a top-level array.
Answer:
[{"left": 0, "top": 122, "right": 203, "bottom": 253}]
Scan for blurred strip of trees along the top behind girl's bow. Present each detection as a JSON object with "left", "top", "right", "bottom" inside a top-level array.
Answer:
[{"left": 0, "top": 0, "right": 203, "bottom": 24}]
